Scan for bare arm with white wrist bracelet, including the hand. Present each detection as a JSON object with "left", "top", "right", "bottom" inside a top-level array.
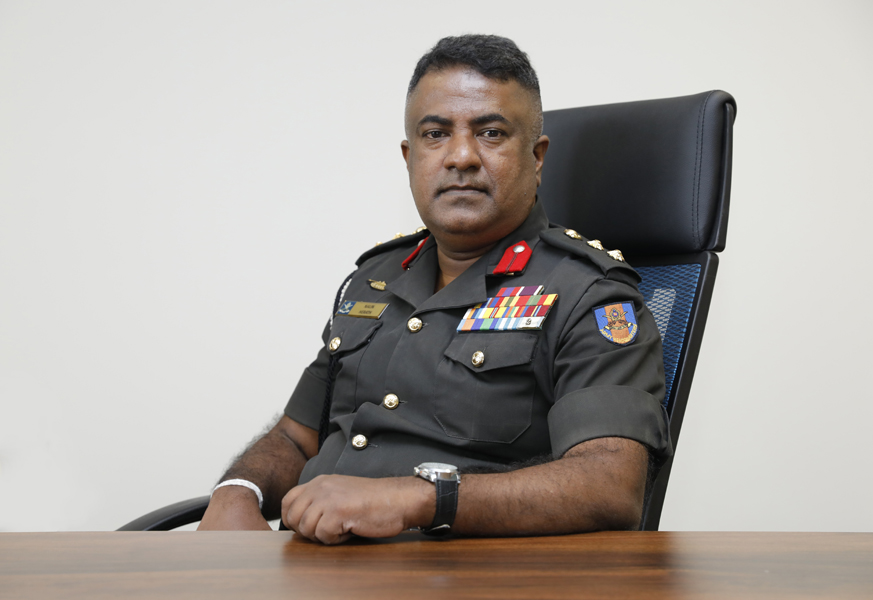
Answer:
[{"left": 198, "top": 415, "right": 318, "bottom": 530}]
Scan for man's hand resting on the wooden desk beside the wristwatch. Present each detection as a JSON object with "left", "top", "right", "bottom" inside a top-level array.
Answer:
[{"left": 282, "top": 475, "right": 436, "bottom": 544}]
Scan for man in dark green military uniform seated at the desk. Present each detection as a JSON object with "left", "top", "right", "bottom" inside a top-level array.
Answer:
[{"left": 200, "top": 36, "right": 672, "bottom": 544}]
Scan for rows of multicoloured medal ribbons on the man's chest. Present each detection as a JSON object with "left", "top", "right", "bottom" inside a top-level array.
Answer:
[{"left": 457, "top": 285, "right": 558, "bottom": 332}]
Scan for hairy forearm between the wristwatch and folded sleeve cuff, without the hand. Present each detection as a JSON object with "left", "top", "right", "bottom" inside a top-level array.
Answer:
[{"left": 452, "top": 438, "right": 648, "bottom": 535}]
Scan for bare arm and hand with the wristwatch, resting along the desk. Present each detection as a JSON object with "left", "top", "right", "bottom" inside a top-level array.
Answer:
[{"left": 282, "top": 438, "right": 648, "bottom": 544}]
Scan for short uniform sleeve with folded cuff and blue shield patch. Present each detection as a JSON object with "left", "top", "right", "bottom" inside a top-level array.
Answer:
[{"left": 548, "top": 279, "right": 673, "bottom": 459}]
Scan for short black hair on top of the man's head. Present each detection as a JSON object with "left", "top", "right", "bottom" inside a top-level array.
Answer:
[{"left": 406, "top": 34, "right": 540, "bottom": 97}]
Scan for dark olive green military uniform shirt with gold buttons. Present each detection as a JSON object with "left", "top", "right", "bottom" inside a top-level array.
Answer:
[{"left": 285, "top": 202, "right": 672, "bottom": 483}]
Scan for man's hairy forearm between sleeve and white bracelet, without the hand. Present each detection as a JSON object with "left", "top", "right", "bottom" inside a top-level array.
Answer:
[{"left": 221, "top": 416, "right": 317, "bottom": 519}]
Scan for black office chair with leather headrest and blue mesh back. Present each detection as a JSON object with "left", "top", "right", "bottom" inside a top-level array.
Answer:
[{"left": 119, "top": 91, "right": 737, "bottom": 531}]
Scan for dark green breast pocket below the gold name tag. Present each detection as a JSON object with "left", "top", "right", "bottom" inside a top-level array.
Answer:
[{"left": 328, "top": 316, "right": 382, "bottom": 418}]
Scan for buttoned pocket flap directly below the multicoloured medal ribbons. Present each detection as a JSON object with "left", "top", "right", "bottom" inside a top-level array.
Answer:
[{"left": 445, "top": 331, "right": 537, "bottom": 373}]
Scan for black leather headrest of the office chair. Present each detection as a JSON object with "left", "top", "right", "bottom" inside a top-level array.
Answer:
[{"left": 538, "top": 90, "right": 736, "bottom": 256}]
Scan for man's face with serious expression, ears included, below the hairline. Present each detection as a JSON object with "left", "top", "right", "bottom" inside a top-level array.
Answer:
[{"left": 401, "top": 67, "right": 549, "bottom": 253}]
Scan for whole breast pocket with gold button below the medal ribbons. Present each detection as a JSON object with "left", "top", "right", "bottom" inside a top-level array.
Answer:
[{"left": 432, "top": 332, "right": 537, "bottom": 443}]
